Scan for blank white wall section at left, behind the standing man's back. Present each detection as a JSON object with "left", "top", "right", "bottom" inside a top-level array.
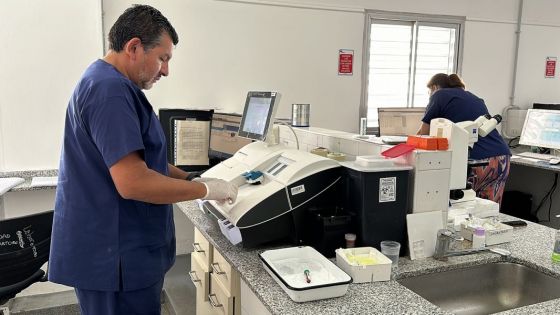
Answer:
[{"left": 0, "top": 0, "right": 102, "bottom": 171}]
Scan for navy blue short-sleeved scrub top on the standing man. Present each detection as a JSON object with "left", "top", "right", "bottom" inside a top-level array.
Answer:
[{"left": 49, "top": 60, "right": 175, "bottom": 291}]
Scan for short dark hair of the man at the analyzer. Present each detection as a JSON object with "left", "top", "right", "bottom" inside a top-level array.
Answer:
[{"left": 109, "top": 4, "right": 179, "bottom": 52}]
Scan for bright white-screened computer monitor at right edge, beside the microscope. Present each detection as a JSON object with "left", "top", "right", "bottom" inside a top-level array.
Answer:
[{"left": 519, "top": 108, "right": 560, "bottom": 149}]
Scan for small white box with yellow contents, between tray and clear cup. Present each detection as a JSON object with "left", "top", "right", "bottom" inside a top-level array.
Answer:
[{"left": 335, "top": 247, "right": 391, "bottom": 283}]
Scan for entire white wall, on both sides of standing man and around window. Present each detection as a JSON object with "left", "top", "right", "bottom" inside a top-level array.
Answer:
[{"left": 0, "top": 0, "right": 560, "bottom": 170}]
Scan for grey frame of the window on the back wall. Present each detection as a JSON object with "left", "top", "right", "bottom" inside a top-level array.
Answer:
[{"left": 359, "top": 10, "right": 466, "bottom": 134}]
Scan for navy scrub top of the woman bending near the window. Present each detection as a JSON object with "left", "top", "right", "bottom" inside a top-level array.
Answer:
[{"left": 422, "top": 88, "right": 511, "bottom": 160}]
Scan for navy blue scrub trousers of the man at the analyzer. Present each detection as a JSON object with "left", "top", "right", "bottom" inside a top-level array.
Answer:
[{"left": 75, "top": 279, "right": 163, "bottom": 315}]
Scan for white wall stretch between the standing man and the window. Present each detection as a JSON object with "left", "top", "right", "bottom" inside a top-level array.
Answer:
[{"left": 104, "top": 0, "right": 364, "bottom": 136}]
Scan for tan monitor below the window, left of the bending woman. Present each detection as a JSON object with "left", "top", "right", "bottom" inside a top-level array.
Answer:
[{"left": 377, "top": 107, "right": 426, "bottom": 136}]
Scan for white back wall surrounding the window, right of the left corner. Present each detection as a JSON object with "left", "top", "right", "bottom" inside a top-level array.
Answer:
[{"left": 100, "top": 0, "right": 560, "bottom": 132}]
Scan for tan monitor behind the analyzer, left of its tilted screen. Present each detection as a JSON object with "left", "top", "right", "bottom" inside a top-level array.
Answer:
[{"left": 209, "top": 113, "right": 252, "bottom": 161}]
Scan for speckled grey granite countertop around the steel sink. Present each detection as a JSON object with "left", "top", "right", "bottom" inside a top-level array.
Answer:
[{"left": 177, "top": 201, "right": 560, "bottom": 315}]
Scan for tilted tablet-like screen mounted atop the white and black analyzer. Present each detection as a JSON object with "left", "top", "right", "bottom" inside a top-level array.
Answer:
[{"left": 237, "top": 92, "right": 280, "bottom": 141}]
